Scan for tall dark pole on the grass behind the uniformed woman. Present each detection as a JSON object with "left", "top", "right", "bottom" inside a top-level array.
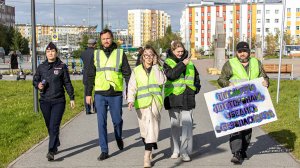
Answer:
[{"left": 31, "top": 0, "right": 39, "bottom": 112}]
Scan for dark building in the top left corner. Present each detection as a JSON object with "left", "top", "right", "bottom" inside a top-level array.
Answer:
[{"left": 0, "top": 0, "right": 15, "bottom": 27}]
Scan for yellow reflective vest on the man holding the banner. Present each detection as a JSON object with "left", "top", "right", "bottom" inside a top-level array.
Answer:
[{"left": 229, "top": 57, "right": 259, "bottom": 84}]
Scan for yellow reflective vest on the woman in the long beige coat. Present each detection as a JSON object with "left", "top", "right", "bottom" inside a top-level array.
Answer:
[{"left": 133, "top": 64, "right": 163, "bottom": 109}]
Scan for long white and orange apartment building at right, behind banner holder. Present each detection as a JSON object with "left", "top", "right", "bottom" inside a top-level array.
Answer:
[{"left": 180, "top": 0, "right": 300, "bottom": 50}]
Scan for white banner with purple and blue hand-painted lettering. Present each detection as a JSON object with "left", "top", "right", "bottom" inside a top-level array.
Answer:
[{"left": 204, "top": 78, "right": 277, "bottom": 137}]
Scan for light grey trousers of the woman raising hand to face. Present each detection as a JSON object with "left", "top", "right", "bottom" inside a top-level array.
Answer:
[{"left": 169, "top": 109, "right": 193, "bottom": 154}]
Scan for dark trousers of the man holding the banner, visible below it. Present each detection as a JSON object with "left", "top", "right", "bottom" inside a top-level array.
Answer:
[{"left": 229, "top": 128, "right": 252, "bottom": 154}]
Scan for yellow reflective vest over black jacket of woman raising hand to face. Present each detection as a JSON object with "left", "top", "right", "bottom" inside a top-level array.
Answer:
[{"left": 164, "top": 58, "right": 196, "bottom": 96}]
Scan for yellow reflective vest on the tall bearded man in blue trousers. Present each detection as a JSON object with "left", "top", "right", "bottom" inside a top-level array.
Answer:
[{"left": 94, "top": 49, "right": 123, "bottom": 91}]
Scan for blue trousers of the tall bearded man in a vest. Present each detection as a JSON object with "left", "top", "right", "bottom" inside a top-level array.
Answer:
[{"left": 95, "top": 94, "right": 123, "bottom": 153}]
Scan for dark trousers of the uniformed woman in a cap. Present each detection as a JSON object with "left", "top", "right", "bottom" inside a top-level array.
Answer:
[{"left": 40, "top": 101, "right": 66, "bottom": 152}]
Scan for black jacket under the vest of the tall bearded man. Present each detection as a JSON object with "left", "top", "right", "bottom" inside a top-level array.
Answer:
[{"left": 86, "top": 42, "right": 131, "bottom": 96}]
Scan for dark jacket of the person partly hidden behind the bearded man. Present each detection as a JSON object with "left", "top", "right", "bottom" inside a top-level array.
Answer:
[{"left": 80, "top": 47, "right": 94, "bottom": 85}]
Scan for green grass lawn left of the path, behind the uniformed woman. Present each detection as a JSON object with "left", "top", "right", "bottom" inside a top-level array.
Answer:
[{"left": 0, "top": 81, "right": 83, "bottom": 167}]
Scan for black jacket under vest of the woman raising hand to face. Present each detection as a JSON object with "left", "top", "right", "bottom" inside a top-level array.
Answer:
[{"left": 164, "top": 50, "right": 201, "bottom": 110}]
